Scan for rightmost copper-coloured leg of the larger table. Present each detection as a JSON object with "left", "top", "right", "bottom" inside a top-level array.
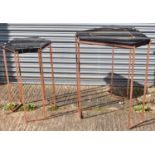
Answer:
[{"left": 142, "top": 42, "right": 151, "bottom": 121}]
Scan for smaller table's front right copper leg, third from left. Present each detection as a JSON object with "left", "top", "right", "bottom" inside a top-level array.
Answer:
[{"left": 38, "top": 49, "right": 46, "bottom": 118}]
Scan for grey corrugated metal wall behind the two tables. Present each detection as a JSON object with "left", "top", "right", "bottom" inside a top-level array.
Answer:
[{"left": 0, "top": 23, "right": 155, "bottom": 85}]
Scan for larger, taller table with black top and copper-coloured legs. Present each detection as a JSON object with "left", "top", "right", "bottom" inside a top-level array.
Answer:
[{"left": 76, "top": 26, "right": 151, "bottom": 128}]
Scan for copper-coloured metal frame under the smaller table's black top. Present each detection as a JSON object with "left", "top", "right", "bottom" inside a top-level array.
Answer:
[{"left": 2, "top": 44, "right": 56, "bottom": 122}]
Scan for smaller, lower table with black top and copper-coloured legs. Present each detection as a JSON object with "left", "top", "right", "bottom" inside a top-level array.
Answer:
[{"left": 1, "top": 37, "right": 56, "bottom": 122}]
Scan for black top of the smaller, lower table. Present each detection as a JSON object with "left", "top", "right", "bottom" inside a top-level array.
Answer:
[{"left": 5, "top": 37, "right": 51, "bottom": 53}]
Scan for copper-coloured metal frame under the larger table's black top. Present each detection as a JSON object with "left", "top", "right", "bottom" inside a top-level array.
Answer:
[{"left": 75, "top": 37, "right": 151, "bottom": 128}]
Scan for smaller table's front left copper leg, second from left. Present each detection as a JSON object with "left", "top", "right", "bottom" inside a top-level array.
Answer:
[{"left": 14, "top": 51, "right": 27, "bottom": 122}]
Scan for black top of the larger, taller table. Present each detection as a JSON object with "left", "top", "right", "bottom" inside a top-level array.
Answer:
[{"left": 76, "top": 26, "right": 150, "bottom": 47}]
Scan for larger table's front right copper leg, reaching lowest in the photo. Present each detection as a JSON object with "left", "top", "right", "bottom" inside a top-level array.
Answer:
[{"left": 128, "top": 47, "right": 136, "bottom": 128}]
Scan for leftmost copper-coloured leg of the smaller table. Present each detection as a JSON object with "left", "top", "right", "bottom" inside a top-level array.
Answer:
[{"left": 2, "top": 49, "right": 13, "bottom": 103}]
